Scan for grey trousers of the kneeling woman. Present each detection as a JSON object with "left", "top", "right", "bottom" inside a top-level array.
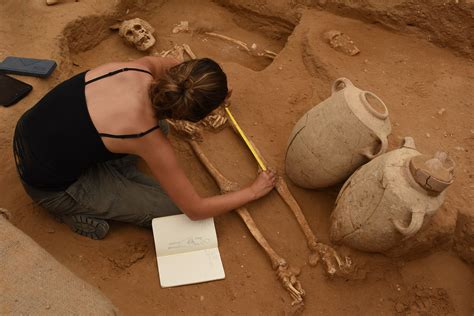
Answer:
[{"left": 23, "top": 156, "right": 181, "bottom": 227}]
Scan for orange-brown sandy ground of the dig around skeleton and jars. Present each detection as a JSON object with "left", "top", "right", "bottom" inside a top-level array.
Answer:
[{"left": 0, "top": 0, "right": 474, "bottom": 315}]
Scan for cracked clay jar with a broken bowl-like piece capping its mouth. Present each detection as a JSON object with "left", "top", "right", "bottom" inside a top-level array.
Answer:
[{"left": 330, "top": 137, "right": 454, "bottom": 252}]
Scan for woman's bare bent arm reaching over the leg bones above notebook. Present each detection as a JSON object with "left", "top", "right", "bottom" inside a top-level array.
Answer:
[{"left": 131, "top": 131, "right": 275, "bottom": 220}]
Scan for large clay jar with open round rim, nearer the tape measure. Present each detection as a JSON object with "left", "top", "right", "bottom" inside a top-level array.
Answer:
[{"left": 285, "top": 78, "right": 391, "bottom": 189}]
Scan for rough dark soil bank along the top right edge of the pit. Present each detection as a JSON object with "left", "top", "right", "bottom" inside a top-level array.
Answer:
[{"left": 217, "top": 0, "right": 474, "bottom": 59}]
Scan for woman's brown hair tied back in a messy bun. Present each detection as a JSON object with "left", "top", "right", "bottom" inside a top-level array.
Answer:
[{"left": 149, "top": 58, "right": 228, "bottom": 122}]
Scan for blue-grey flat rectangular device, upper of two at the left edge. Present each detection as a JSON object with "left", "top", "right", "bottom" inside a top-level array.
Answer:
[{"left": 0, "top": 56, "right": 56, "bottom": 78}]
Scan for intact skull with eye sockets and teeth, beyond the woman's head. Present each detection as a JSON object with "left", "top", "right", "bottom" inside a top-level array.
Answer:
[{"left": 119, "top": 18, "right": 156, "bottom": 51}]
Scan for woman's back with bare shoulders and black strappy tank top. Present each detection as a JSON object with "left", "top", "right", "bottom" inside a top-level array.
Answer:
[{"left": 14, "top": 63, "right": 157, "bottom": 190}]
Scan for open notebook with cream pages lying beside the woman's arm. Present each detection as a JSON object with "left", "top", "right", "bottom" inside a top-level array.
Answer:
[{"left": 152, "top": 214, "right": 225, "bottom": 287}]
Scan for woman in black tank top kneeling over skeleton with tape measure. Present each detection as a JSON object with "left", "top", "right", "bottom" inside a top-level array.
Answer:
[{"left": 14, "top": 57, "right": 275, "bottom": 239}]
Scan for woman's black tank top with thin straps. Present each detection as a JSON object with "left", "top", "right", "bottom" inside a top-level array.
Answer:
[{"left": 13, "top": 68, "right": 159, "bottom": 191}]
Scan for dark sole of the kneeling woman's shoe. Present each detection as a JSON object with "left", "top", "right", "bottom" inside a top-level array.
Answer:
[{"left": 60, "top": 215, "right": 109, "bottom": 239}]
